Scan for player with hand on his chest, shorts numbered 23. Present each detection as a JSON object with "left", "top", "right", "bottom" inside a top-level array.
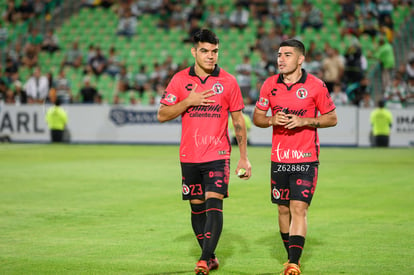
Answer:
[{"left": 158, "top": 29, "right": 251, "bottom": 275}]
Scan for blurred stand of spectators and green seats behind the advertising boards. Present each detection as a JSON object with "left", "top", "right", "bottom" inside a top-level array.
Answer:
[{"left": 0, "top": 0, "right": 414, "bottom": 108}]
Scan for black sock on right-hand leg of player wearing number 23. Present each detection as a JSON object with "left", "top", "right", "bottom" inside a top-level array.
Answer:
[{"left": 200, "top": 198, "right": 223, "bottom": 261}]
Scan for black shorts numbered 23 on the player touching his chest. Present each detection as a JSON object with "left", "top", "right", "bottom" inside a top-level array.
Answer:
[{"left": 181, "top": 159, "right": 230, "bottom": 200}]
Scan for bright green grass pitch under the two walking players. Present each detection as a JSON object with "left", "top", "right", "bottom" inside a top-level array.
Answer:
[{"left": 0, "top": 144, "right": 414, "bottom": 275}]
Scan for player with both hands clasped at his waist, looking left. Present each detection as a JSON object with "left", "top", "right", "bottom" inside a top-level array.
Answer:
[{"left": 253, "top": 39, "right": 337, "bottom": 275}]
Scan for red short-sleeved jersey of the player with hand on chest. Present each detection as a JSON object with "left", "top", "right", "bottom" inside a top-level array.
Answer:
[{"left": 160, "top": 65, "right": 244, "bottom": 163}]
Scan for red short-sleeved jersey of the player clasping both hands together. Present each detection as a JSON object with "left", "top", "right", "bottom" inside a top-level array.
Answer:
[{"left": 256, "top": 69, "right": 336, "bottom": 163}]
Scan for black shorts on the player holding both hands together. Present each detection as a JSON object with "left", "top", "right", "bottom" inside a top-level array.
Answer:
[{"left": 271, "top": 162, "right": 318, "bottom": 205}]
